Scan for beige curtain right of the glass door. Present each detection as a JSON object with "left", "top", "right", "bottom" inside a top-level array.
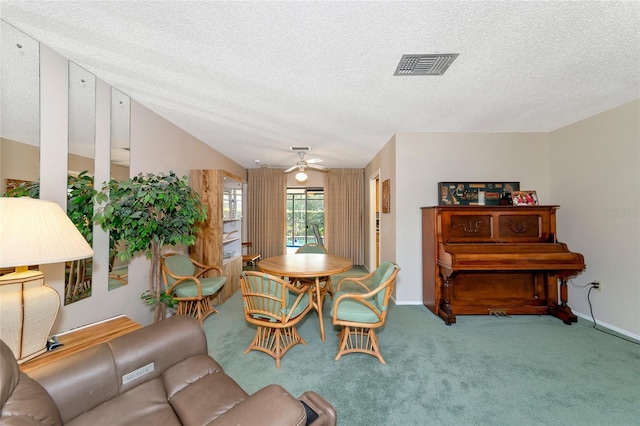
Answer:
[{"left": 324, "top": 169, "right": 364, "bottom": 265}]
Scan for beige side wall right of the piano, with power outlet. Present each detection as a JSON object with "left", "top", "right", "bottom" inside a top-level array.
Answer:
[{"left": 550, "top": 100, "right": 640, "bottom": 338}]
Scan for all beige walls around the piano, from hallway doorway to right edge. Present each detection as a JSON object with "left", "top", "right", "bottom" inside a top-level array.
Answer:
[{"left": 365, "top": 100, "right": 640, "bottom": 338}]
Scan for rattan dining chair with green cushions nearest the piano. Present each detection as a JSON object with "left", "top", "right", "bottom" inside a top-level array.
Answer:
[{"left": 331, "top": 262, "right": 400, "bottom": 364}]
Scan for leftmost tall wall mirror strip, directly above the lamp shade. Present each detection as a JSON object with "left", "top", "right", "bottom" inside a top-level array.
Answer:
[{"left": 0, "top": 21, "right": 40, "bottom": 197}]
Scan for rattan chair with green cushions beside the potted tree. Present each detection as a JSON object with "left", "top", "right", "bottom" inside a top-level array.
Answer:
[{"left": 160, "top": 253, "right": 227, "bottom": 325}]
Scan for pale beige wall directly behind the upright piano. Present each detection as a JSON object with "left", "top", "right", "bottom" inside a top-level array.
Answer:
[{"left": 392, "top": 133, "right": 549, "bottom": 304}]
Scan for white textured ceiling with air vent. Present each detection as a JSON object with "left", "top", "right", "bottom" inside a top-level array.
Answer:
[{"left": 0, "top": 1, "right": 640, "bottom": 168}]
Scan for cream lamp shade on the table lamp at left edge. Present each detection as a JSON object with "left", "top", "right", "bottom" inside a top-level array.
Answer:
[{"left": 0, "top": 197, "right": 93, "bottom": 267}]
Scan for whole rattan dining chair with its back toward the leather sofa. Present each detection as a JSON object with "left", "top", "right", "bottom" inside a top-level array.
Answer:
[{"left": 240, "top": 271, "right": 312, "bottom": 368}]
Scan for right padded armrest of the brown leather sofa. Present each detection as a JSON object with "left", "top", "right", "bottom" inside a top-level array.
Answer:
[{"left": 209, "top": 385, "right": 307, "bottom": 426}]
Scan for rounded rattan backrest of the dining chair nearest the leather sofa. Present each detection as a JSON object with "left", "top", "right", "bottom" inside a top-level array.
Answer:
[{"left": 240, "top": 271, "right": 289, "bottom": 322}]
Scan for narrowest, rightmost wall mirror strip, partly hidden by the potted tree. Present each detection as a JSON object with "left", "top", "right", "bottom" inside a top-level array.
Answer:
[{"left": 109, "top": 88, "right": 131, "bottom": 290}]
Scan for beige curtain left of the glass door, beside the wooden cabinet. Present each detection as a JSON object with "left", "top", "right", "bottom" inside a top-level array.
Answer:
[{"left": 246, "top": 169, "right": 287, "bottom": 259}]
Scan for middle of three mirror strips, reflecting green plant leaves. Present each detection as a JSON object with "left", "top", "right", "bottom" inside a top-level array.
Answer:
[{"left": 64, "top": 62, "right": 96, "bottom": 305}]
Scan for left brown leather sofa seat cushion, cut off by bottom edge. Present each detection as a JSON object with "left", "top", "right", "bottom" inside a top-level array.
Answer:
[{"left": 66, "top": 378, "right": 182, "bottom": 426}]
